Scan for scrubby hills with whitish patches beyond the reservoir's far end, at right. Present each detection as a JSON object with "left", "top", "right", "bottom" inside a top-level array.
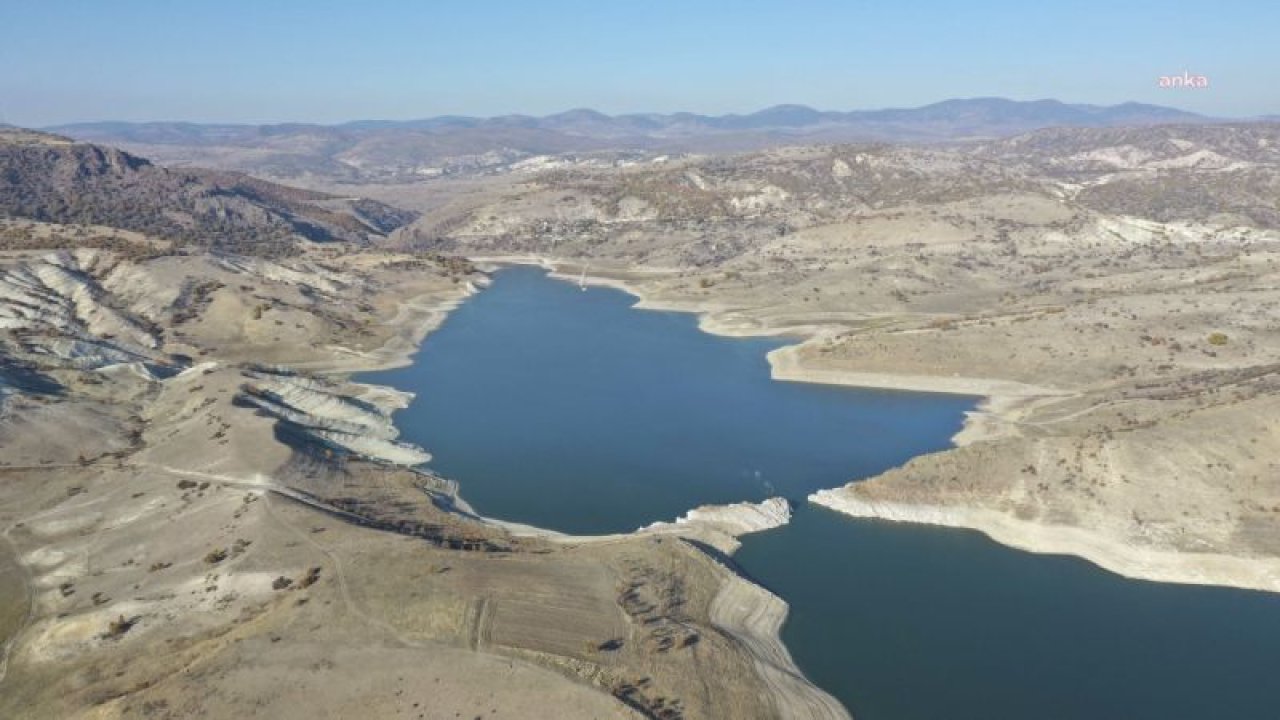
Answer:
[{"left": 381, "top": 123, "right": 1280, "bottom": 260}]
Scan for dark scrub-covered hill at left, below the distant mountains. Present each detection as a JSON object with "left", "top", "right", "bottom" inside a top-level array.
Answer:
[{"left": 0, "top": 129, "right": 416, "bottom": 254}]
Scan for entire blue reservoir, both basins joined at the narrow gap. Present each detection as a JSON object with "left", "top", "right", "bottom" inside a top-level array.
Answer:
[{"left": 358, "top": 268, "right": 1280, "bottom": 720}]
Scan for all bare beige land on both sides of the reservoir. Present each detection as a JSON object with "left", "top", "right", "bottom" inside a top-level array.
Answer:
[{"left": 0, "top": 123, "right": 1280, "bottom": 719}]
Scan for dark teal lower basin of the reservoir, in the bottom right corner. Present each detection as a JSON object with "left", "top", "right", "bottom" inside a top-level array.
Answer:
[{"left": 735, "top": 505, "right": 1280, "bottom": 720}]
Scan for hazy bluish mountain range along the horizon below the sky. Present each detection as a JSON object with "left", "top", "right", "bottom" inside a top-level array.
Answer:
[{"left": 49, "top": 97, "right": 1228, "bottom": 182}]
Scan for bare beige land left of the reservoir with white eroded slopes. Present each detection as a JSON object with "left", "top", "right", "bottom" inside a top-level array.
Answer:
[{"left": 0, "top": 227, "right": 847, "bottom": 719}]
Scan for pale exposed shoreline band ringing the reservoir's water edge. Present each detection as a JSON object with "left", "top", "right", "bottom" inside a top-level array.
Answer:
[{"left": 333, "top": 255, "right": 1280, "bottom": 719}]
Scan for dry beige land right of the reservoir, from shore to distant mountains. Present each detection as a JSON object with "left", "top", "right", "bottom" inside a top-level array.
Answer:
[{"left": 370, "top": 124, "right": 1280, "bottom": 591}]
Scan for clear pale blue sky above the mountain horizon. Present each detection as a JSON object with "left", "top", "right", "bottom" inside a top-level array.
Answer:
[{"left": 0, "top": 0, "right": 1280, "bottom": 126}]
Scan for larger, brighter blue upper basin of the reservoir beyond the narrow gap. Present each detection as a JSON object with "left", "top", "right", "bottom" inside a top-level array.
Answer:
[{"left": 361, "top": 268, "right": 974, "bottom": 534}]
